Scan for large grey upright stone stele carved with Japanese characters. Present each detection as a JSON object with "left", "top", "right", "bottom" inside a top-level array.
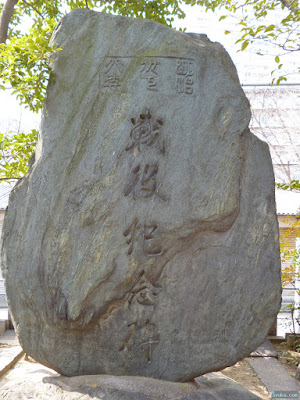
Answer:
[{"left": 2, "top": 10, "right": 281, "bottom": 381}]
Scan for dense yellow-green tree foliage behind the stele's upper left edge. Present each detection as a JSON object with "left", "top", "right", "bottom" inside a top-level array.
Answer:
[{"left": 0, "top": 0, "right": 185, "bottom": 112}]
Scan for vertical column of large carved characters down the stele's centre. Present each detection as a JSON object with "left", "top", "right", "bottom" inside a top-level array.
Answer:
[{"left": 120, "top": 105, "right": 165, "bottom": 363}]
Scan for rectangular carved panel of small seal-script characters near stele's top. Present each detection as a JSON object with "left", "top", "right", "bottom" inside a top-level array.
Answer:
[{"left": 101, "top": 56, "right": 197, "bottom": 96}]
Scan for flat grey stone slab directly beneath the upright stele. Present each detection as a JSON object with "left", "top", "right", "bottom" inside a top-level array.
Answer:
[{"left": 43, "top": 372, "right": 259, "bottom": 400}]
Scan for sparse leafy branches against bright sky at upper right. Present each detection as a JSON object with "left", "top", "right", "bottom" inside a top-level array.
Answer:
[{"left": 186, "top": 0, "right": 300, "bottom": 84}]
